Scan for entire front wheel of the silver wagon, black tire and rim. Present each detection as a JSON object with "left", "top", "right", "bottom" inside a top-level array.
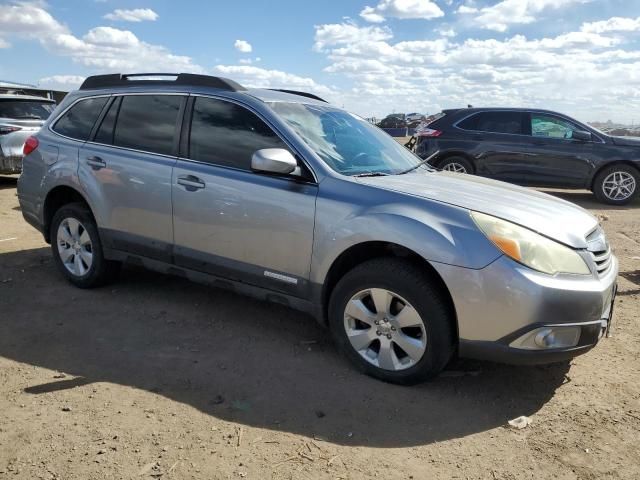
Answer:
[{"left": 329, "top": 258, "right": 454, "bottom": 385}]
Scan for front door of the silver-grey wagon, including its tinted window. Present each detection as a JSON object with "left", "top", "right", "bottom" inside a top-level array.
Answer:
[{"left": 172, "top": 97, "right": 318, "bottom": 298}]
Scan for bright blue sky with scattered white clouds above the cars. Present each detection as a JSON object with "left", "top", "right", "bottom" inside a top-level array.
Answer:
[{"left": 0, "top": 0, "right": 640, "bottom": 122}]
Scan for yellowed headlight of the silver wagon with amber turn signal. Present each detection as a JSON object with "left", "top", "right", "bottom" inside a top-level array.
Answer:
[{"left": 471, "top": 212, "right": 591, "bottom": 275}]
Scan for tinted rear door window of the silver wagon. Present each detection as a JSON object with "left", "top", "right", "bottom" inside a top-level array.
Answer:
[{"left": 113, "top": 95, "right": 183, "bottom": 155}]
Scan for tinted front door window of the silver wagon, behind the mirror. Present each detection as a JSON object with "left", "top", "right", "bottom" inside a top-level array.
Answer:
[{"left": 189, "top": 97, "right": 287, "bottom": 170}]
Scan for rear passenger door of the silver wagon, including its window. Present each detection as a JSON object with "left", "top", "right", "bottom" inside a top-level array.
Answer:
[{"left": 78, "top": 94, "right": 187, "bottom": 262}]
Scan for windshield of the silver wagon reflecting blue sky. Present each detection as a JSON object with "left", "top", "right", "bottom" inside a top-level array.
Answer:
[{"left": 270, "top": 102, "right": 427, "bottom": 175}]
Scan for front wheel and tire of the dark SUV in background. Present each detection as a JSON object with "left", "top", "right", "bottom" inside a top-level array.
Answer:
[{"left": 593, "top": 164, "right": 640, "bottom": 205}]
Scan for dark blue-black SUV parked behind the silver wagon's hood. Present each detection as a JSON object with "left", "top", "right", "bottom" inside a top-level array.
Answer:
[{"left": 416, "top": 108, "right": 640, "bottom": 205}]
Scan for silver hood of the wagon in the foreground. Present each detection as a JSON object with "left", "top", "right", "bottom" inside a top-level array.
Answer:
[{"left": 358, "top": 172, "right": 598, "bottom": 248}]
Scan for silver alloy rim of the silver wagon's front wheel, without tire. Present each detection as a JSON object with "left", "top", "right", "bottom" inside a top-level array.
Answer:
[{"left": 344, "top": 288, "right": 427, "bottom": 371}]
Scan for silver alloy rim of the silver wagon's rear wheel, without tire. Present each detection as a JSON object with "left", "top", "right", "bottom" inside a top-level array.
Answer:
[{"left": 57, "top": 217, "right": 93, "bottom": 277}]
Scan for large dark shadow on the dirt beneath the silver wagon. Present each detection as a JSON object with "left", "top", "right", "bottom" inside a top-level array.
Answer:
[{"left": 0, "top": 248, "right": 569, "bottom": 447}]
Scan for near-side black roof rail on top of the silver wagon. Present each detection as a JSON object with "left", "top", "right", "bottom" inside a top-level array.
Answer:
[{"left": 80, "top": 73, "right": 246, "bottom": 92}]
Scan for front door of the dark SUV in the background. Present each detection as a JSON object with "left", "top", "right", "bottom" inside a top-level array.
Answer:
[{"left": 528, "top": 112, "right": 601, "bottom": 187}]
